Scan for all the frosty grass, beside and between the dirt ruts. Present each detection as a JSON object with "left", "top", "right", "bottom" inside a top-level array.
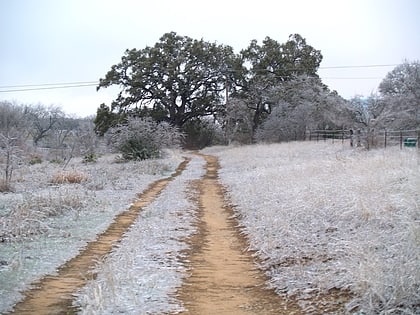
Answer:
[{"left": 0, "top": 142, "right": 420, "bottom": 314}]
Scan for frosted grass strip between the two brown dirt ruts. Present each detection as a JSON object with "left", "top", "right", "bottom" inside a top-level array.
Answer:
[{"left": 75, "top": 157, "right": 204, "bottom": 315}]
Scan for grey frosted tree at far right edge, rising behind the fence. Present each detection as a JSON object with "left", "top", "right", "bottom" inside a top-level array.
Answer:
[{"left": 377, "top": 61, "right": 420, "bottom": 129}]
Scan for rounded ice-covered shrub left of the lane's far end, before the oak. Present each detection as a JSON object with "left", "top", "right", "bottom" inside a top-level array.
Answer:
[{"left": 106, "top": 118, "right": 182, "bottom": 160}]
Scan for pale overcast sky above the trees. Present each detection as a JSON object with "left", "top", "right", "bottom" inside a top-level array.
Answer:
[{"left": 0, "top": 0, "right": 420, "bottom": 116}]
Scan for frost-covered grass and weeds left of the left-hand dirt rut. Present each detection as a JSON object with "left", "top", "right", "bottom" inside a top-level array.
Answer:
[{"left": 0, "top": 151, "right": 182, "bottom": 313}]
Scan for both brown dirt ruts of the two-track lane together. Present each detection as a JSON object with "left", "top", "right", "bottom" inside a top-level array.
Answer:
[{"left": 9, "top": 156, "right": 300, "bottom": 315}]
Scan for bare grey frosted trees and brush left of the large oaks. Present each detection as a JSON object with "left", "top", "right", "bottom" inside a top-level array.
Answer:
[{"left": 0, "top": 101, "right": 99, "bottom": 192}]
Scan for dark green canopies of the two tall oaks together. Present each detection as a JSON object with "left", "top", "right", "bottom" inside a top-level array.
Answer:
[{"left": 95, "top": 32, "right": 322, "bottom": 134}]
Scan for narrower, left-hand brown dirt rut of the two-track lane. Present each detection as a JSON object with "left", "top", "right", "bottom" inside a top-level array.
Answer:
[{"left": 10, "top": 158, "right": 190, "bottom": 314}]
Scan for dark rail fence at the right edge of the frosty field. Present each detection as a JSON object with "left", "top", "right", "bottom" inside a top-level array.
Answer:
[{"left": 306, "top": 129, "right": 420, "bottom": 149}]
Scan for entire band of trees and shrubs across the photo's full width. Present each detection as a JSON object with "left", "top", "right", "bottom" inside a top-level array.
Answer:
[{"left": 0, "top": 32, "right": 420, "bottom": 190}]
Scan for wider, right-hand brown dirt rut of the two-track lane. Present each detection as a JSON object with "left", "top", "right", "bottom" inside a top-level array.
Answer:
[{"left": 178, "top": 155, "right": 301, "bottom": 315}]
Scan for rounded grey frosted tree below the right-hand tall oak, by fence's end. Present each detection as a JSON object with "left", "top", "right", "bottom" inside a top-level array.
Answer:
[{"left": 255, "top": 75, "right": 352, "bottom": 142}]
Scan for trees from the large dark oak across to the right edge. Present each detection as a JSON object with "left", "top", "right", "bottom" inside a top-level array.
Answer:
[{"left": 95, "top": 32, "right": 420, "bottom": 147}]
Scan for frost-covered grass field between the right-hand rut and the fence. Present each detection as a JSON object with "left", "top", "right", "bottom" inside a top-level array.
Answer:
[{"left": 205, "top": 142, "right": 420, "bottom": 314}]
